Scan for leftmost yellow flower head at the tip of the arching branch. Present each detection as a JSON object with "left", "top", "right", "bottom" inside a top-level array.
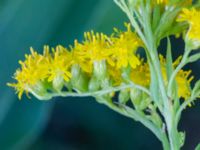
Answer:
[{"left": 8, "top": 48, "right": 48, "bottom": 99}]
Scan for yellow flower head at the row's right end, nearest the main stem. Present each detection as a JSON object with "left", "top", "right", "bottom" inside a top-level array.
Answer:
[{"left": 111, "top": 24, "right": 143, "bottom": 69}]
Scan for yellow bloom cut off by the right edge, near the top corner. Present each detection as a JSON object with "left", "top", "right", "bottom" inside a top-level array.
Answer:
[{"left": 177, "top": 8, "right": 200, "bottom": 41}]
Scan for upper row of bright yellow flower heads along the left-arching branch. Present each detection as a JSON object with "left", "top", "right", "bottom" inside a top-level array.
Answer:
[{"left": 9, "top": 24, "right": 142, "bottom": 98}]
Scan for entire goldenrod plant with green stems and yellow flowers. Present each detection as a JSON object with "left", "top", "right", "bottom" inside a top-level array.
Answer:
[{"left": 8, "top": 0, "right": 200, "bottom": 150}]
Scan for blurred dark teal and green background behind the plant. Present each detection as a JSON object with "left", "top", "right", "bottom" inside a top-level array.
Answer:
[{"left": 0, "top": 0, "right": 200, "bottom": 150}]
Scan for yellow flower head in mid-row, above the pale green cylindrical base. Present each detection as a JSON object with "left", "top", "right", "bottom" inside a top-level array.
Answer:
[{"left": 72, "top": 31, "right": 114, "bottom": 73}]
